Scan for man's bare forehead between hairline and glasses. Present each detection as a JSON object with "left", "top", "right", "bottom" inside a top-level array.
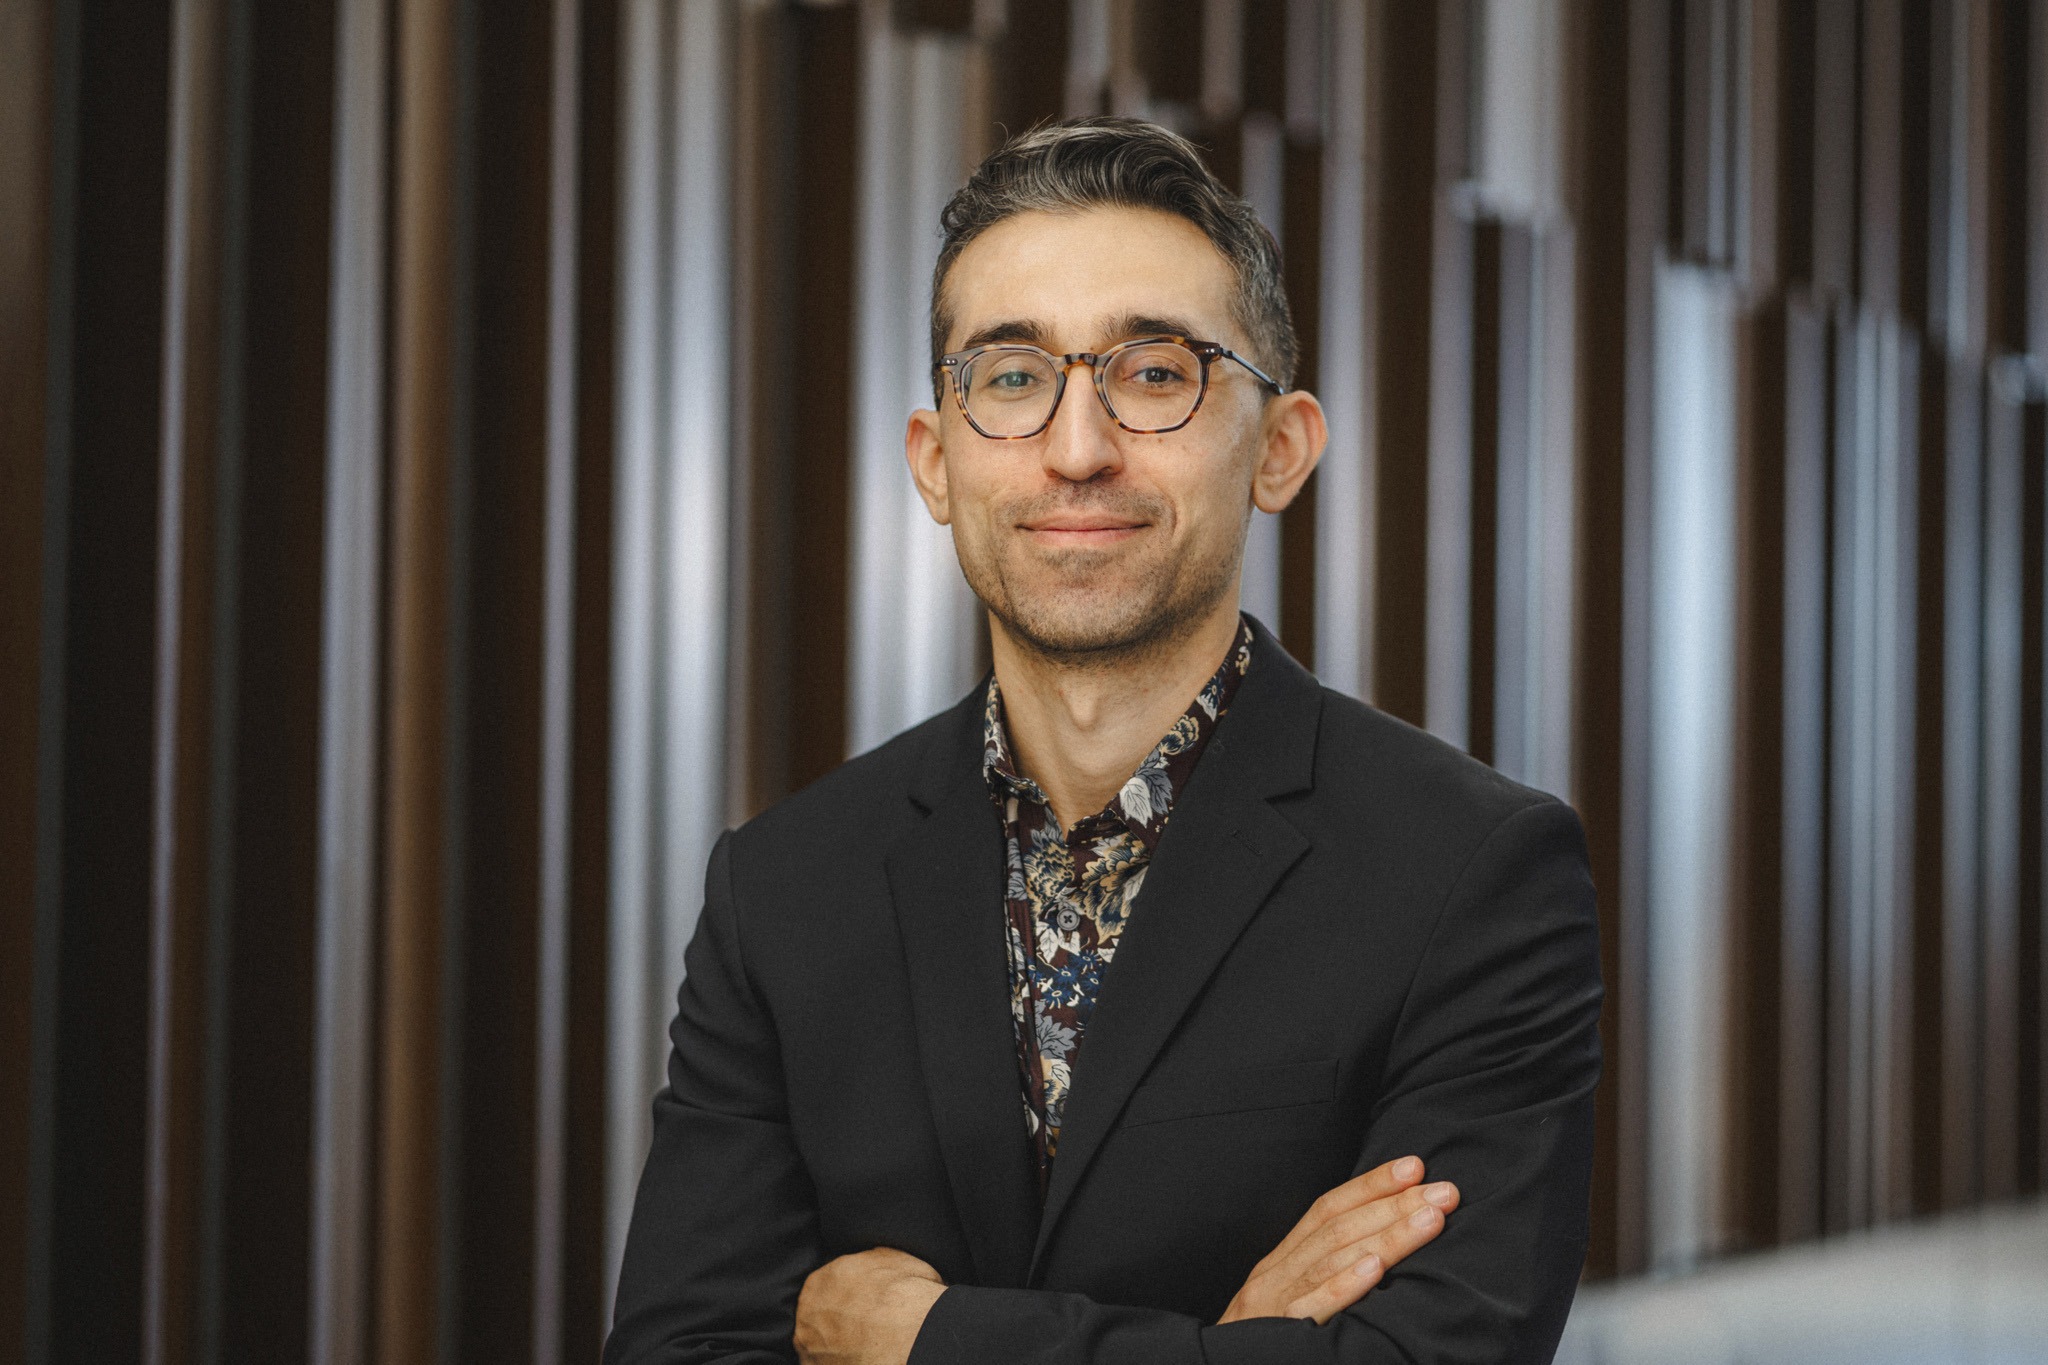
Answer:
[{"left": 946, "top": 209, "right": 1241, "bottom": 350}]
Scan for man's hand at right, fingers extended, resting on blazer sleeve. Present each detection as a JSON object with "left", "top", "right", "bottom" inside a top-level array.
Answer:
[{"left": 1219, "top": 1156, "right": 1458, "bottom": 1326}]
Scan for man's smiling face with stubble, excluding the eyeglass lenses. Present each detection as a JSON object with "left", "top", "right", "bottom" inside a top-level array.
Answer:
[{"left": 911, "top": 209, "right": 1266, "bottom": 663}]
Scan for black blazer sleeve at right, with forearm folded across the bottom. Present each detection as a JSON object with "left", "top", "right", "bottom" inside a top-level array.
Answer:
[{"left": 911, "top": 800, "right": 1602, "bottom": 1365}]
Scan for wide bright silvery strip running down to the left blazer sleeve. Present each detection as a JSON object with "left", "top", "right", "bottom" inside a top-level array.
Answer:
[{"left": 604, "top": 0, "right": 731, "bottom": 1309}]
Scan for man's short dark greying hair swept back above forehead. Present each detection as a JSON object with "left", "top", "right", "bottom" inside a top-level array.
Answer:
[{"left": 932, "top": 117, "right": 1300, "bottom": 389}]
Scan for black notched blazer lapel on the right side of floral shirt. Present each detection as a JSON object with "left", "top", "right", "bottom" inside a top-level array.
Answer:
[{"left": 1032, "top": 622, "right": 1321, "bottom": 1283}]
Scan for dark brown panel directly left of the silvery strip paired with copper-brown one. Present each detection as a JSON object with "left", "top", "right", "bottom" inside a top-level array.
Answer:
[{"left": 199, "top": 0, "right": 336, "bottom": 1363}]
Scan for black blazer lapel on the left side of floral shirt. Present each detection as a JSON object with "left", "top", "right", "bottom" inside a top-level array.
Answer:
[{"left": 887, "top": 690, "right": 1038, "bottom": 1287}]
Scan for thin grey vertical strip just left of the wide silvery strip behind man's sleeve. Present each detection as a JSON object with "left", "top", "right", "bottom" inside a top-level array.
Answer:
[{"left": 532, "top": 0, "right": 582, "bottom": 1365}]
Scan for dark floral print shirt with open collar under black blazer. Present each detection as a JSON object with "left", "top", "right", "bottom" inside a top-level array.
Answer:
[{"left": 981, "top": 622, "right": 1251, "bottom": 1193}]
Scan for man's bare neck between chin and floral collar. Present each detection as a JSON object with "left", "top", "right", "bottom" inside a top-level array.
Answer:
[{"left": 989, "top": 591, "right": 1237, "bottom": 829}]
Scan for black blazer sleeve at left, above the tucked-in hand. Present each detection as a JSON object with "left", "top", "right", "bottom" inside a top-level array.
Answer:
[{"left": 604, "top": 833, "right": 823, "bottom": 1365}]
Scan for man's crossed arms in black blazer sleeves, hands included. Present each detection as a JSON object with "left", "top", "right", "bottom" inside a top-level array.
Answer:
[{"left": 604, "top": 802, "right": 1599, "bottom": 1365}]
